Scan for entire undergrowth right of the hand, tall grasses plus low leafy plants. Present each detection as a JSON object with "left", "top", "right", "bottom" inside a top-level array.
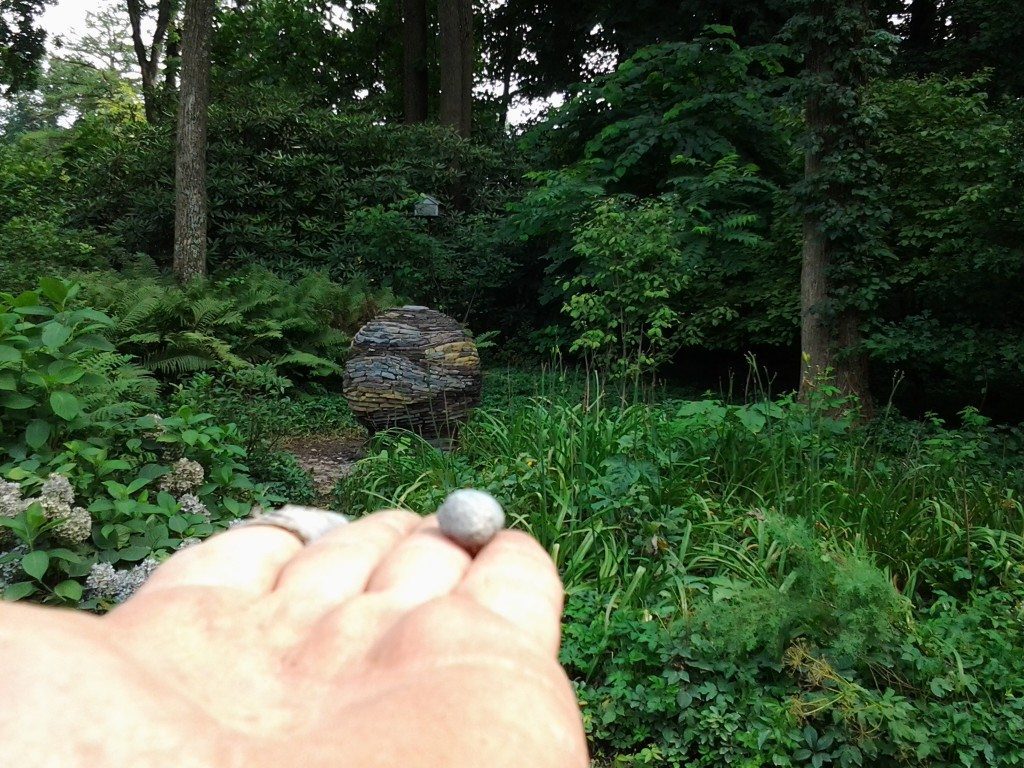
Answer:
[{"left": 337, "top": 381, "right": 1024, "bottom": 766}]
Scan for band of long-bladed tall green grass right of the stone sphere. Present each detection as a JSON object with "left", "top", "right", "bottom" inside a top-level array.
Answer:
[{"left": 338, "top": 385, "right": 1024, "bottom": 610}]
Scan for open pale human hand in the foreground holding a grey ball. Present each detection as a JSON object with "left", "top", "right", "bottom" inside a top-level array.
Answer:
[{"left": 0, "top": 511, "right": 588, "bottom": 768}]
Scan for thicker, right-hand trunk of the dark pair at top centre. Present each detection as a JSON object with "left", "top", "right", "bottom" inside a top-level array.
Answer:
[{"left": 438, "top": 0, "right": 474, "bottom": 136}]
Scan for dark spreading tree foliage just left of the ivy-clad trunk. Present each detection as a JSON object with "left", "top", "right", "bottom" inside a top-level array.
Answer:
[{"left": 511, "top": 28, "right": 797, "bottom": 358}]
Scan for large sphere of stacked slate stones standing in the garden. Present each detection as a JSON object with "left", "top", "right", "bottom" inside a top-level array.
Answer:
[{"left": 344, "top": 306, "right": 481, "bottom": 439}]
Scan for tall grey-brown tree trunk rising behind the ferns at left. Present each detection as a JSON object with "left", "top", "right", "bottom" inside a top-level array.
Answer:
[{"left": 174, "top": 0, "right": 214, "bottom": 284}]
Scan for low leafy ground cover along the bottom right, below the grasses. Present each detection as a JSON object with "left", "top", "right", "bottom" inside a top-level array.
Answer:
[{"left": 561, "top": 582, "right": 1024, "bottom": 768}]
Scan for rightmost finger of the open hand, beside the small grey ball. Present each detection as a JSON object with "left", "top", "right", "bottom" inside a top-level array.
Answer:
[{"left": 455, "top": 530, "right": 563, "bottom": 653}]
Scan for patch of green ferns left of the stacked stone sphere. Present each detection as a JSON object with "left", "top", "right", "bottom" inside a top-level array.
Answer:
[{"left": 74, "top": 268, "right": 393, "bottom": 378}]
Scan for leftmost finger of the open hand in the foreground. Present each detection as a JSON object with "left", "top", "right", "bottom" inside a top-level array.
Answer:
[{"left": 138, "top": 525, "right": 302, "bottom": 598}]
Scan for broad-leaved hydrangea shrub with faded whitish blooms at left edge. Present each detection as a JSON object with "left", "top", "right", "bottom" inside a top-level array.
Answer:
[{"left": 0, "top": 279, "right": 261, "bottom": 608}]
